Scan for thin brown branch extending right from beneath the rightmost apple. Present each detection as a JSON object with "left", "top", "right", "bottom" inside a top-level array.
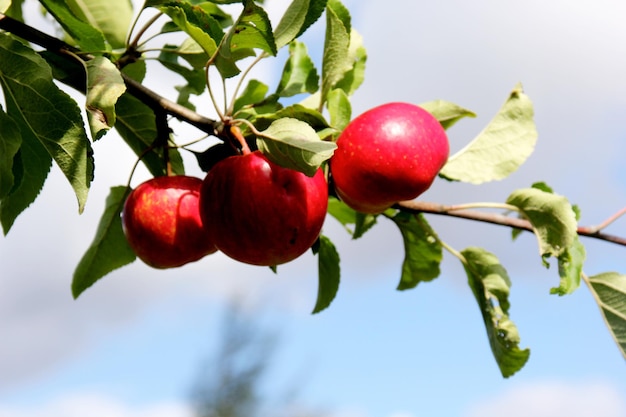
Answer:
[{"left": 394, "top": 201, "right": 626, "bottom": 246}]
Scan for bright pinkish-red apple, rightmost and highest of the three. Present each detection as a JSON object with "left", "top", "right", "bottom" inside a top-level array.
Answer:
[{"left": 330, "top": 103, "right": 450, "bottom": 213}]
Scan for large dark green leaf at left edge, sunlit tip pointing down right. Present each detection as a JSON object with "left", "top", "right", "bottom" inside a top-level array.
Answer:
[{"left": 0, "top": 34, "right": 94, "bottom": 212}]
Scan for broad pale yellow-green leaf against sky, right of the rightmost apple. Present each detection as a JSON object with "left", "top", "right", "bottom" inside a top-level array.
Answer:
[{"left": 440, "top": 85, "right": 537, "bottom": 184}]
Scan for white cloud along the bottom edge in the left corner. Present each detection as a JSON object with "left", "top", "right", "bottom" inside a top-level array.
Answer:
[{"left": 0, "top": 393, "right": 193, "bottom": 417}]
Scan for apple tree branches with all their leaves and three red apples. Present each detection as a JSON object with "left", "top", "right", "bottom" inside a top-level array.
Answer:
[{"left": 0, "top": 0, "right": 626, "bottom": 377}]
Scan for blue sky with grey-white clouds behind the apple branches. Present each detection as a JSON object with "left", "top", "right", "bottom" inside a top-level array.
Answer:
[{"left": 0, "top": 0, "right": 626, "bottom": 417}]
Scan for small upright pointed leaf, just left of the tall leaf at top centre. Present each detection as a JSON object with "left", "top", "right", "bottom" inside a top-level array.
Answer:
[{"left": 276, "top": 41, "right": 319, "bottom": 97}]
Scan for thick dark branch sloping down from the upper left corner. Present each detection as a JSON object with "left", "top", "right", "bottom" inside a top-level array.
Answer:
[{"left": 0, "top": 13, "right": 221, "bottom": 136}]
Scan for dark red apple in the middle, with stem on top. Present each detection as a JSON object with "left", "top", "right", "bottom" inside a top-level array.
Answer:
[{"left": 200, "top": 151, "right": 328, "bottom": 266}]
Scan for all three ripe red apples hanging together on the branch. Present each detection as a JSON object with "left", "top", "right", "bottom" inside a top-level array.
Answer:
[{"left": 122, "top": 103, "right": 449, "bottom": 268}]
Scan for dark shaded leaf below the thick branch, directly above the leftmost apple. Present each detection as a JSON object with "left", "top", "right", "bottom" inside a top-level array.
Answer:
[{"left": 115, "top": 93, "right": 184, "bottom": 177}]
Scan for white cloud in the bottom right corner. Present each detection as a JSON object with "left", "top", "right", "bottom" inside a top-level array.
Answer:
[{"left": 465, "top": 381, "right": 626, "bottom": 417}]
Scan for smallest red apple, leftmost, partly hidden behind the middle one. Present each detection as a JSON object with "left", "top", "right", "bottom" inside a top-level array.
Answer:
[{"left": 122, "top": 175, "right": 217, "bottom": 268}]
